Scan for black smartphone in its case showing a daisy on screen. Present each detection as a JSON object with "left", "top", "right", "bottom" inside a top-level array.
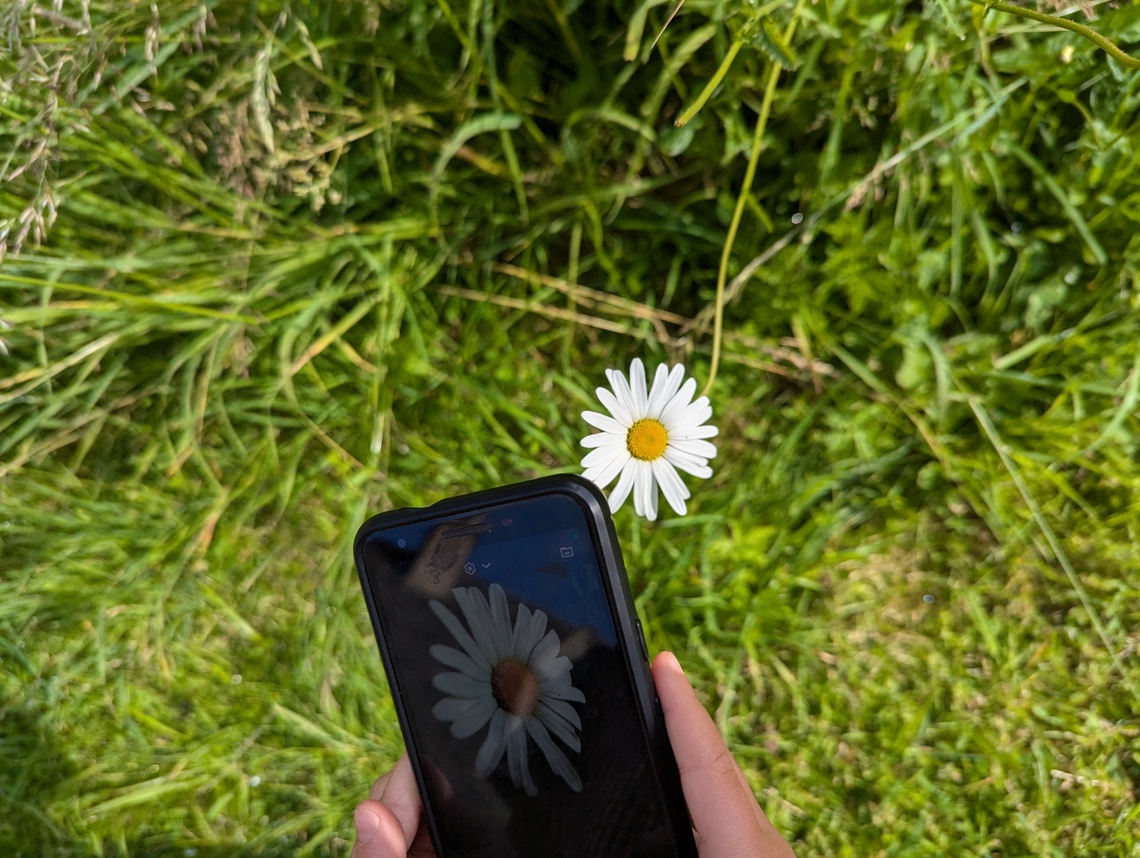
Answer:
[{"left": 355, "top": 475, "right": 697, "bottom": 858}]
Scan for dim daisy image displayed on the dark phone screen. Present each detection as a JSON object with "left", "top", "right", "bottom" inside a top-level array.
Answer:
[{"left": 429, "top": 583, "right": 586, "bottom": 795}]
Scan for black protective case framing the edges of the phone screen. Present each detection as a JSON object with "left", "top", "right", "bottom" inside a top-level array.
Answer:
[{"left": 352, "top": 474, "right": 697, "bottom": 858}]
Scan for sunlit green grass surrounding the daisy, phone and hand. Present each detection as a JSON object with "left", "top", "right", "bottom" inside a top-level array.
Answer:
[{"left": 0, "top": 0, "right": 1140, "bottom": 858}]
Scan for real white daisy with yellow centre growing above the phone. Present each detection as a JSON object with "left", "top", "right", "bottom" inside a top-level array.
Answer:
[{"left": 581, "top": 358, "right": 717, "bottom": 521}]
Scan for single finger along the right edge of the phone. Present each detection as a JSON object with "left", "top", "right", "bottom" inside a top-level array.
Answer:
[{"left": 653, "top": 652, "right": 795, "bottom": 858}]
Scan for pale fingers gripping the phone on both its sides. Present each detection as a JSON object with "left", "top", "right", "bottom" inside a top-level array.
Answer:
[{"left": 352, "top": 652, "right": 796, "bottom": 858}]
